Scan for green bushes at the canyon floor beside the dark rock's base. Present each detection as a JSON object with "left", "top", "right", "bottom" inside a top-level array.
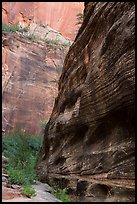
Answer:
[{"left": 2, "top": 131, "right": 42, "bottom": 197}]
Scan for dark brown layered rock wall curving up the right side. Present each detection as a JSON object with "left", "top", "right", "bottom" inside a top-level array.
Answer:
[{"left": 37, "top": 2, "right": 135, "bottom": 201}]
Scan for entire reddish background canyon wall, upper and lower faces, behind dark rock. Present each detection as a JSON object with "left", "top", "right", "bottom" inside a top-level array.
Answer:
[{"left": 2, "top": 2, "right": 83, "bottom": 134}]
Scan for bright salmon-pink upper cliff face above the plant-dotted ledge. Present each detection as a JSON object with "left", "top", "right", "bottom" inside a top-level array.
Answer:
[{"left": 2, "top": 2, "right": 84, "bottom": 40}]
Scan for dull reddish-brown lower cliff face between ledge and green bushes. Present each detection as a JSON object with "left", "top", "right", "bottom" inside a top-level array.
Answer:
[{"left": 2, "top": 33, "right": 68, "bottom": 135}]
